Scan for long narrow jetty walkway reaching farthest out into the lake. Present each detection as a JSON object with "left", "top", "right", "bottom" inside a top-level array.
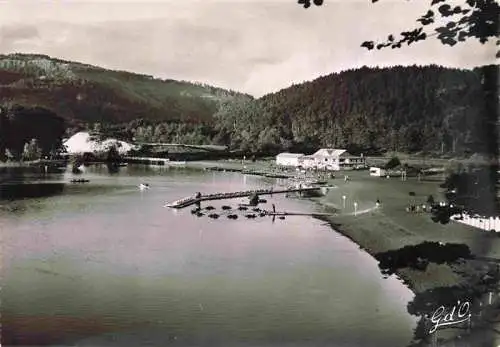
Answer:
[{"left": 165, "top": 187, "right": 321, "bottom": 208}]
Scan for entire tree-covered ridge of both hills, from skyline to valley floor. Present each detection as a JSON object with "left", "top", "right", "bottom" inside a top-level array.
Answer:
[{"left": 0, "top": 54, "right": 499, "bottom": 155}]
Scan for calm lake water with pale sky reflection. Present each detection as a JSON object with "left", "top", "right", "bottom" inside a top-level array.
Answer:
[{"left": 0, "top": 167, "right": 415, "bottom": 347}]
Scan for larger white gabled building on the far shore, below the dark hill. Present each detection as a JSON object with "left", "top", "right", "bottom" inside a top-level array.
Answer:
[{"left": 301, "top": 148, "right": 366, "bottom": 171}]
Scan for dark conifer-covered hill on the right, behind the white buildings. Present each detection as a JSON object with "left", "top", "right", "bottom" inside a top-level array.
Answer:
[{"left": 230, "top": 66, "right": 498, "bottom": 157}]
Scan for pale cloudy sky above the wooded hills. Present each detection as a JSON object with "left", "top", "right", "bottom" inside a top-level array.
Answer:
[{"left": 0, "top": 0, "right": 496, "bottom": 97}]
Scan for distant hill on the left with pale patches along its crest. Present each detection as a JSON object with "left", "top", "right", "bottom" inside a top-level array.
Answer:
[{"left": 0, "top": 54, "right": 250, "bottom": 125}]
